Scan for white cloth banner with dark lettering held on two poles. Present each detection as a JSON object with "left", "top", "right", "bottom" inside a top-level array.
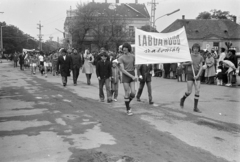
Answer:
[{"left": 135, "top": 27, "right": 191, "bottom": 64}]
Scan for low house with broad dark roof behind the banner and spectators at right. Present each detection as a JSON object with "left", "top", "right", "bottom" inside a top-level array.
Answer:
[{"left": 162, "top": 16, "right": 240, "bottom": 52}]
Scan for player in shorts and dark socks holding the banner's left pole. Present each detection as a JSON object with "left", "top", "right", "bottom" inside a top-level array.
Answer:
[{"left": 118, "top": 43, "right": 137, "bottom": 115}]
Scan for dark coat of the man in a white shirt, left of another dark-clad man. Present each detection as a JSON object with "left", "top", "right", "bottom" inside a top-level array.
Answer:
[{"left": 57, "top": 55, "right": 71, "bottom": 77}]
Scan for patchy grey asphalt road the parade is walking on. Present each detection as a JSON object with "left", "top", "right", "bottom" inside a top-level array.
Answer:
[{"left": 0, "top": 61, "right": 240, "bottom": 162}]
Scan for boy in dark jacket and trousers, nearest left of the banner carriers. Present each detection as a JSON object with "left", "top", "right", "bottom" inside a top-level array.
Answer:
[{"left": 96, "top": 52, "right": 112, "bottom": 103}]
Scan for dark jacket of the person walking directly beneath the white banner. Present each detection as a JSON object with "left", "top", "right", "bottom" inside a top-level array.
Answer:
[{"left": 137, "top": 64, "right": 153, "bottom": 82}]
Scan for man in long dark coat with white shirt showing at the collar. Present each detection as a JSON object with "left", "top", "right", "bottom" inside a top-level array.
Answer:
[{"left": 57, "top": 48, "right": 71, "bottom": 87}]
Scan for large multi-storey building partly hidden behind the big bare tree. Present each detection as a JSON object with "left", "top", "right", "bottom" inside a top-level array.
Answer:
[{"left": 64, "top": 0, "right": 150, "bottom": 50}]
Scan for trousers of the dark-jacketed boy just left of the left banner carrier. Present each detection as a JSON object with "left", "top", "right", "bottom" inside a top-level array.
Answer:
[{"left": 99, "top": 78, "right": 112, "bottom": 100}]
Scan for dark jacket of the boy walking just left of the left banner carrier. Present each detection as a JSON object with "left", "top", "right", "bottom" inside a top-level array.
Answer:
[{"left": 96, "top": 60, "right": 112, "bottom": 79}]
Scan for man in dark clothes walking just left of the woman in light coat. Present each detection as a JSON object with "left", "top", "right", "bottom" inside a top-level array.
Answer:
[{"left": 71, "top": 49, "right": 82, "bottom": 86}]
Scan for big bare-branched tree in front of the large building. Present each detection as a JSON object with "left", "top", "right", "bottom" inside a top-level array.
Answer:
[{"left": 69, "top": 3, "right": 131, "bottom": 52}]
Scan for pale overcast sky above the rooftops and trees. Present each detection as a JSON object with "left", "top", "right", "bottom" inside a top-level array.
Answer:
[{"left": 0, "top": 0, "right": 240, "bottom": 41}]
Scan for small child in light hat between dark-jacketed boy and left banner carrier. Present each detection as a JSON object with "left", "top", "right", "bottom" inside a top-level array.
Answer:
[{"left": 111, "top": 59, "right": 121, "bottom": 102}]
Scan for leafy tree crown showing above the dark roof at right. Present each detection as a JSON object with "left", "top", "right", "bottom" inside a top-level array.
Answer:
[{"left": 196, "top": 9, "right": 234, "bottom": 20}]
